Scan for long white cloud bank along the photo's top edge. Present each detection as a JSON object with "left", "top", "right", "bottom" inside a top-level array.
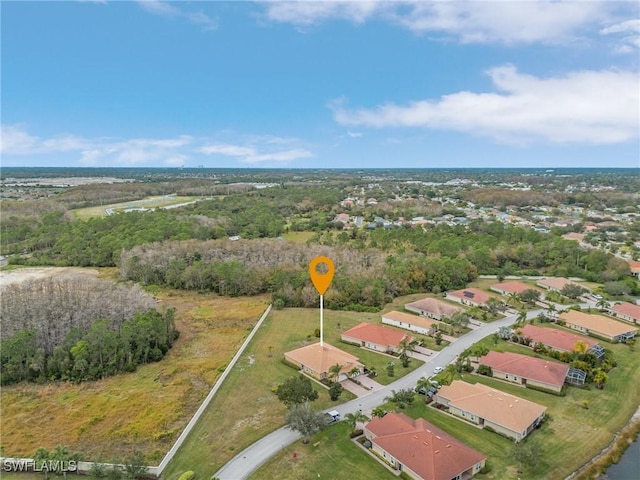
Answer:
[{"left": 263, "top": 0, "right": 629, "bottom": 43}]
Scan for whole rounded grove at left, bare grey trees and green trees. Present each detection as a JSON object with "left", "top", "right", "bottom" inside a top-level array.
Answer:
[{"left": 0, "top": 279, "right": 178, "bottom": 384}]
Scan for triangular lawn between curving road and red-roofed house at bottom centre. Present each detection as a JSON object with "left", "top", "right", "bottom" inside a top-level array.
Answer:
[{"left": 249, "top": 422, "right": 397, "bottom": 480}]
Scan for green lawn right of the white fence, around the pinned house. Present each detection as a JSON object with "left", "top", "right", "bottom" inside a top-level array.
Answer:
[{"left": 164, "top": 308, "right": 421, "bottom": 480}]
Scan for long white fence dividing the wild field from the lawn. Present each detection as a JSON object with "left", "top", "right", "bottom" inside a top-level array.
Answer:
[{"left": 0, "top": 305, "right": 271, "bottom": 477}]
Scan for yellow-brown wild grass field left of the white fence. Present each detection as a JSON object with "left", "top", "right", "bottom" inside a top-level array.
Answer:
[{"left": 0, "top": 286, "right": 268, "bottom": 464}]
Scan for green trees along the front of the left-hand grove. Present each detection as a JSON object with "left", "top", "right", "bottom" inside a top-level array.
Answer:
[{"left": 0, "top": 309, "right": 177, "bottom": 385}]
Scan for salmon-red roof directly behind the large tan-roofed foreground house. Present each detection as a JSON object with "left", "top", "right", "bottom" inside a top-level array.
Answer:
[{"left": 479, "top": 351, "right": 569, "bottom": 387}]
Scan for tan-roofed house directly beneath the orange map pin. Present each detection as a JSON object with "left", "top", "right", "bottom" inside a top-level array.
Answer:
[{"left": 284, "top": 342, "right": 364, "bottom": 381}]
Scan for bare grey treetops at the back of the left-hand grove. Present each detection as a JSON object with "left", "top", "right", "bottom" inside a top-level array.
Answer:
[{"left": 0, "top": 276, "right": 156, "bottom": 355}]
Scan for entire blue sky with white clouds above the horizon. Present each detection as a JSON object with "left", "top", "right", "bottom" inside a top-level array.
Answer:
[{"left": 0, "top": 0, "right": 640, "bottom": 168}]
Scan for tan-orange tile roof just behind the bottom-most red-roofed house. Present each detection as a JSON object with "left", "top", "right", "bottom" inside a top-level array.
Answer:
[{"left": 437, "top": 380, "right": 547, "bottom": 432}]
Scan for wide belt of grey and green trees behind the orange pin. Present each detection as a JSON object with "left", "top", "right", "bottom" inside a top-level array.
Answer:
[{"left": 119, "top": 240, "right": 477, "bottom": 309}]
